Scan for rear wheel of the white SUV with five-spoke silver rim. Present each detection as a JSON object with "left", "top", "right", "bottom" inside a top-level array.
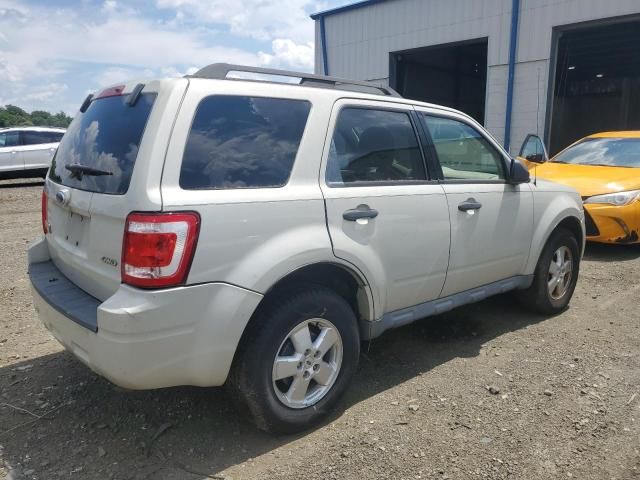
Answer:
[{"left": 228, "top": 286, "right": 360, "bottom": 433}]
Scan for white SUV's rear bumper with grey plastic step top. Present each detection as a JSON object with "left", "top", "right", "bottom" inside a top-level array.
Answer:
[{"left": 29, "top": 240, "right": 262, "bottom": 389}]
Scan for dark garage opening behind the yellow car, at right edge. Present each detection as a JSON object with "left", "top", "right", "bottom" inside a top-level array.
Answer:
[{"left": 549, "top": 20, "right": 640, "bottom": 154}]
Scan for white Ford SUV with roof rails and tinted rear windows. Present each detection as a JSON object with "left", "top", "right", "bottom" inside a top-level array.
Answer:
[{"left": 29, "top": 64, "right": 584, "bottom": 432}]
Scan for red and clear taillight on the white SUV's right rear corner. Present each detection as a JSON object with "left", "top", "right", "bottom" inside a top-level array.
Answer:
[{"left": 121, "top": 212, "right": 200, "bottom": 288}]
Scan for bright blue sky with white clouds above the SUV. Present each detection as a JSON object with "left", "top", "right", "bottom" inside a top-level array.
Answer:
[{"left": 0, "top": 0, "right": 344, "bottom": 115}]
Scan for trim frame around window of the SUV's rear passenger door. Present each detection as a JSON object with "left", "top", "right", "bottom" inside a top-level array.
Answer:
[{"left": 324, "top": 103, "right": 438, "bottom": 188}]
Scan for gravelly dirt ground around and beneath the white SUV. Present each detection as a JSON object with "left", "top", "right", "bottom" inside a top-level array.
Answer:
[{"left": 0, "top": 177, "right": 640, "bottom": 480}]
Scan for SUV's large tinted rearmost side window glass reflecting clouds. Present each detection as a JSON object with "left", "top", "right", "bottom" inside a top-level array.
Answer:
[{"left": 180, "top": 95, "right": 311, "bottom": 190}]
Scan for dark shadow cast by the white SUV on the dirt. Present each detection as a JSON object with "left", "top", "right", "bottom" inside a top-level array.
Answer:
[{"left": 0, "top": 295, "right": 553, "bottom": 479}]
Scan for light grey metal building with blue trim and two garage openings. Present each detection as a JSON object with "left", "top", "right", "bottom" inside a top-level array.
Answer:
[{"left": 311, "top": 0, "right": 640, "bottom": 153}]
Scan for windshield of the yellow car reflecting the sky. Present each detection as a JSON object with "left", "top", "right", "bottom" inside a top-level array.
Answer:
[{"left": 552, "top": 138, "right": 640, "bottom": 168}]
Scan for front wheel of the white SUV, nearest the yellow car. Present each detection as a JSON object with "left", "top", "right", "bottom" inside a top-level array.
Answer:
[{"left": 518, "top": 228, "right": 580, "bottom": 315}]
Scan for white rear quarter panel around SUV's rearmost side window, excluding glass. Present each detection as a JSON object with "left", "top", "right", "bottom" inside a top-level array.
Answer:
[{"left": 162, "top": 79, "right": 350, "bottom": 293}]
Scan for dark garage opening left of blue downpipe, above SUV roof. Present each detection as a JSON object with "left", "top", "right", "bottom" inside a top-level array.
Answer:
[{"left": 390, "top": 39, "right": 488, "bottom": 123}]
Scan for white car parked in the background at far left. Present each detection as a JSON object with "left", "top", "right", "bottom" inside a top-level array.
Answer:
[{"left": 0, "top": 127, "right": 65, "bottom": 179}]
